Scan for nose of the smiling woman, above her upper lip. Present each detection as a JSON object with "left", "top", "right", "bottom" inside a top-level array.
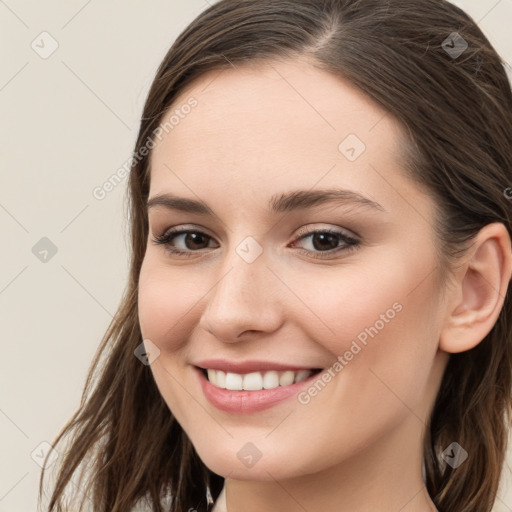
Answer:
[{"left": 199, "top": 240, "right": 285, "bottom": 343}]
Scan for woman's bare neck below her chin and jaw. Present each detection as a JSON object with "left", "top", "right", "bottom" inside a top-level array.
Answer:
[{"left": 225, "top": 414, "right": 437, "bottom": 512}]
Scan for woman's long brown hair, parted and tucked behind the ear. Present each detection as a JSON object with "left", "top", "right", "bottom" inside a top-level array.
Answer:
[{"left": 40, "top": 0, "right": 512, "bottom": 512}]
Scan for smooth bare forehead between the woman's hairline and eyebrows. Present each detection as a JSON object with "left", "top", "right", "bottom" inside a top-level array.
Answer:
[{"left": 150, "top": 61, "right": 426, "bottom": 218}]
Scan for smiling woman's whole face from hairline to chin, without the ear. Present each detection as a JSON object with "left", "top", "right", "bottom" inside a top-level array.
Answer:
[{"left": 139, "top": 61, "right": 447, "bottom": 480}]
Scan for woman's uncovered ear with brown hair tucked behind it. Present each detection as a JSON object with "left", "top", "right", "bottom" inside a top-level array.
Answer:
[{"left": 439, "top": 222, "right": 512, "bottom": 353}]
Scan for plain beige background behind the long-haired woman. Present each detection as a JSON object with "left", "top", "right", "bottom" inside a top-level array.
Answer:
[{"left": 0, "top": 0, "right": 512, "bottom": 512}]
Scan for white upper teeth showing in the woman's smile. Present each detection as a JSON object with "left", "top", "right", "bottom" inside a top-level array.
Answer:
[{"left": 207, "top": 368, "right": 313, "bottom": 391}]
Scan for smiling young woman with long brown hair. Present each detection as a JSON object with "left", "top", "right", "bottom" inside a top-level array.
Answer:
[{"left": 41, "top": 0, "right": 512, "bottom": 512}]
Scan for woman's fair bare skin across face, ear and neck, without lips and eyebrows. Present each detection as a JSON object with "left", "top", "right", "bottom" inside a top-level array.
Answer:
[{"left": 139, "top": 60, "right": 512, "bottom": 512}]
